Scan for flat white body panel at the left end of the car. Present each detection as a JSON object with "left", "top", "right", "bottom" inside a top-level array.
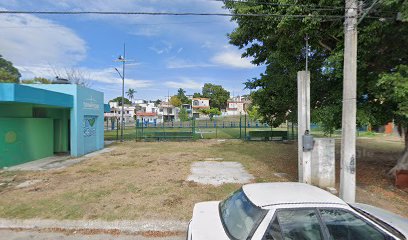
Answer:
[{"left": 191, "top": 201, "right": 229, "bottom": 240}]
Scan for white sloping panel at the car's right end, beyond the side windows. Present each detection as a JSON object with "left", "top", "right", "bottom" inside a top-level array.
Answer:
[{"left": 350, "top": 203, "right": 408, "bottom": 238}]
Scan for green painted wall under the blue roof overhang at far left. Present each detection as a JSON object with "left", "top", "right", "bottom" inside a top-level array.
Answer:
[{"left": 0, "top": 118, "right": 54, "bottom": 167}]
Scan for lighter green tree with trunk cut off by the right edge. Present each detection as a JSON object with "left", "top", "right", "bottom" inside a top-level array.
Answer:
[{"left": 377, "top": 65, "right": 408, "bottom": 174}]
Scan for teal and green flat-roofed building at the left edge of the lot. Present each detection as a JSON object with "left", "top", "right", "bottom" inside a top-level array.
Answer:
[{"left": 0, "top": 83, "right": 104, "bottom": 168}]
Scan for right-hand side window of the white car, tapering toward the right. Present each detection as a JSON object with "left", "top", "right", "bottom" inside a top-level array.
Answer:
[{"left": 319, "top": 209, "right": 390, "bottom": 240}]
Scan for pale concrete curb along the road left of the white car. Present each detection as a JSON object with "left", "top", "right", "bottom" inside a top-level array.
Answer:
[{"left": 0, "top": 218, "right": 188, "bottom": 233}]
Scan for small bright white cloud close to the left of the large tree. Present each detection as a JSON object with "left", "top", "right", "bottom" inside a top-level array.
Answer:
[{"left": 211, "top": 50, "right": 256, "bottom": 68}]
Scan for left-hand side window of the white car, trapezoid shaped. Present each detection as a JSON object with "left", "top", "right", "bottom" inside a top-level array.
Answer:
[{"left": 264, "top": 209, "right": 323, "bottom": 240}]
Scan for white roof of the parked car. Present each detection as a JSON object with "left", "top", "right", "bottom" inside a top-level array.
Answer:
[{"left": 242, "top": 182, "right": 347, "bottom": 207}]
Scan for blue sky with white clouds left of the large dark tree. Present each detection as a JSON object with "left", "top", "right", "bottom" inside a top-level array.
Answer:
[{"left": 0, "top": 0, "right": 264, "bottom": 101}]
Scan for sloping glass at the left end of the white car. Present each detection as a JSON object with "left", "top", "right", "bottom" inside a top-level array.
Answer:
[{"left": 220, "top": 189, "right": 266, "bottom": 239}]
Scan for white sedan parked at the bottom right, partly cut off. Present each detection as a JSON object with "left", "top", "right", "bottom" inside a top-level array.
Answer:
[{"left": 187, "top": 183, "right": 408, "bottom": 240}]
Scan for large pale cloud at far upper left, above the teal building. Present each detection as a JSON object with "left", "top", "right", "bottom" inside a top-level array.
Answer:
[{"left": 0, "top": 14, "right": 87, "bottom": 66}]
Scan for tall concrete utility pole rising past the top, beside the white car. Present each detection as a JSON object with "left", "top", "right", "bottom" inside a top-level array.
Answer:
[{"left": 340, "top": 0, "right": 357, "bottom": 203}]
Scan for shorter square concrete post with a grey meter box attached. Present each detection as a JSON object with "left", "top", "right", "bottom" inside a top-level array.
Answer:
[{"left": 297, "top": 71, "right": 312, "bottom": 184}]
